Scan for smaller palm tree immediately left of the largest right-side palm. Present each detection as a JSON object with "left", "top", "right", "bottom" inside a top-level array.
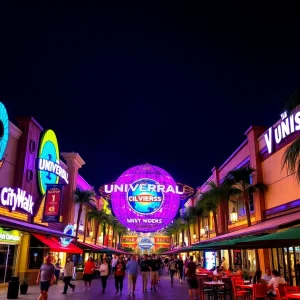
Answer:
[{"left": 199, "top": 182, "right": 221, "bottom": 236}]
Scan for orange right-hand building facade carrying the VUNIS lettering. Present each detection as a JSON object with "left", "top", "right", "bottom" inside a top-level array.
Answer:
[{"left": 187, "top": 112, "right": 300, "bottom": 283}]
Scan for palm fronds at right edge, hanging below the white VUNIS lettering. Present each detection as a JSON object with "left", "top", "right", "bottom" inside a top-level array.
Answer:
[{"left": 281, "top": 137, "right": 300, "bottom": 184}]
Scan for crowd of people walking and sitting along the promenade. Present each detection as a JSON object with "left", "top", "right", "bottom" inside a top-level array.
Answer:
[{"left": 37, "top": 254, "right": 285, "bottom": 300}]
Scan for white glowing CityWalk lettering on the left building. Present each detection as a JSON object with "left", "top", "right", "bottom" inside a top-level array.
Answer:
[{"left": 0, "top": 187, "right": 34, "bottom": 214}]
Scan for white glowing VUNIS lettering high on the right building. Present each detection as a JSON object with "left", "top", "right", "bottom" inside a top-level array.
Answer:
[{"left": 264, "top": 111, "right": 300, "bottom": 154}]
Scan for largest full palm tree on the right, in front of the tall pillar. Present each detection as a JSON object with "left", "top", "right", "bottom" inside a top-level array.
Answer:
[{"left": 226, "top": 167, "right": 267, "bottom": 226}]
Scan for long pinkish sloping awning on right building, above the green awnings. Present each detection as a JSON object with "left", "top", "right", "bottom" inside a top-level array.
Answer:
[{"left": 194, "top": 212, "right": 300, "bottom": 245}]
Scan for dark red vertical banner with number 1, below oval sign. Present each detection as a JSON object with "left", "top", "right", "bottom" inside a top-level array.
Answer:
[{"left": 43, "top": 184, "right": 63, "bottom": 223}]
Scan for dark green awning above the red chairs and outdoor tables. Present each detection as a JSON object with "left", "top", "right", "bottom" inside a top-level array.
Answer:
[{"left": 241, "top": 227, "right": 300, "bottom": 249}]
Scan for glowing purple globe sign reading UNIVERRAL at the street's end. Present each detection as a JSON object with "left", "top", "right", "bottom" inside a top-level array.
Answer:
[{"left": 100, "top": 164, "right": 189, "bottom": 232}]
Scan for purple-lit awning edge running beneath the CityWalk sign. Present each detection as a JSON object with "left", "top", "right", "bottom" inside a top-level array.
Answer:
[{"left": 0, "top": 216, "right": 70, "bottom": 237}]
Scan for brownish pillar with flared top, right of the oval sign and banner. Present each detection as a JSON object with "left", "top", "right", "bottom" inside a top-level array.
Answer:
[{"left": 61, "top": 152, "right": 85, "bottom": 226}]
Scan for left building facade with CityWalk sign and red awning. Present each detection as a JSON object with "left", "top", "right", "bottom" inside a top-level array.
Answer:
[{"left": 0, "top": 102, "right": 112, "bottom": 286}]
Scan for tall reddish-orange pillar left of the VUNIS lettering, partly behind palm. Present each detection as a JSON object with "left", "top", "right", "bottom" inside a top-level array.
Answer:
[{"left": 245, "top": 126, "right": 265, "bottom": 222}]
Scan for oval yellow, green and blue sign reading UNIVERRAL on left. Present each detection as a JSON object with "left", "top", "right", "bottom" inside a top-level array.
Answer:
[{"left": 37, "top": 129, "right": 69, "bottom": 195}]
